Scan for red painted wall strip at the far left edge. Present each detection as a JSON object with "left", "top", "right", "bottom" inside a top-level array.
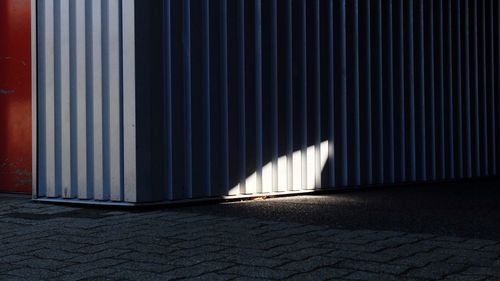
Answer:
[{"left": 0, "top": 0, "right": 32, "bottom": 193}]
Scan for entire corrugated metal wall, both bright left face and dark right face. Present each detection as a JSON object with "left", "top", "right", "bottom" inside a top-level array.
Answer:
[{"left": 38, "top": 0, "right": 500, "bottom": 202}]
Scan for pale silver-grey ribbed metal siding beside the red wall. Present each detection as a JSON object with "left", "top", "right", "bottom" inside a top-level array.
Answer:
[{"left": 33, "top": 0, "right": 135, "bottom": 201}]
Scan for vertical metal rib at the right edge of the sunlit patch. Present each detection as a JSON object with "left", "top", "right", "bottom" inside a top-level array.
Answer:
[{"left": 327, "top": 1, "right": 337, "bottom": 187}]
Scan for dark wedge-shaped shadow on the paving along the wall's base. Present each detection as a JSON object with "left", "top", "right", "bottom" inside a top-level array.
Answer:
[{"left": 175, "top": 180, "right": 500, "bottom": 240}]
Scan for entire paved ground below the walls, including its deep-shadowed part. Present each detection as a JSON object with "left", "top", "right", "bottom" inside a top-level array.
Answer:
[{"left": 0, "top": 181, "right": 500, "bottom": 281}]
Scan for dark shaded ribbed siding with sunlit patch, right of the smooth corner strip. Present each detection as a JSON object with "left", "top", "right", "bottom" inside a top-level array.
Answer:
[{"left": 164, "top": 0, "right": 500, "bottom": 199}]
